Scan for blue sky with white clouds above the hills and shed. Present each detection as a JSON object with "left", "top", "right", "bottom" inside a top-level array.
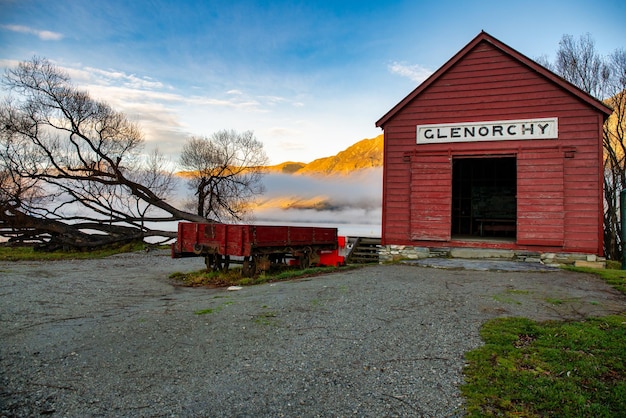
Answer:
[{"left": 0, "top": 0, "right": 626, "bottom": 167}]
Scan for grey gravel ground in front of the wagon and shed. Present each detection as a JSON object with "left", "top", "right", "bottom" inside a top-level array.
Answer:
[{"left": 0, "top": 251, "right": 626, "bottom": 417}]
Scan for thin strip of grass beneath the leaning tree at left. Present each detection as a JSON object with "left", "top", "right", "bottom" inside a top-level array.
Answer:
[{"left": 0, "top": 243, "right": 145, "bottom": 261}]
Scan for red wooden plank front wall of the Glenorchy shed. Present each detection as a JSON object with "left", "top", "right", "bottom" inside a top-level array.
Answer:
[{"left": 383, "top": 42, "right": 602, "bottom": 253}]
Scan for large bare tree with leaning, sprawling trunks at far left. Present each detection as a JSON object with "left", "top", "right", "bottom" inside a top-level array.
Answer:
[{"left": 0, "top": 58, "right": 204, "bottom": 248}]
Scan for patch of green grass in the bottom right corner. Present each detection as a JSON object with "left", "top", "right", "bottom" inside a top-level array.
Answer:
[{"left": 461, "top": 315, "right": 626, "bottom": 417}]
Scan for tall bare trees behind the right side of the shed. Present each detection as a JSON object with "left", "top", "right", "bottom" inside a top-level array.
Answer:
[{"left": 544, "top": 34, "right": 626, "bottom": 260}]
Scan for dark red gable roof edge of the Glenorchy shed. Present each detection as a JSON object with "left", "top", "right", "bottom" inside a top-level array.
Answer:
[{"left": 376, "top": 31, "right": 613, "bottom": 128}]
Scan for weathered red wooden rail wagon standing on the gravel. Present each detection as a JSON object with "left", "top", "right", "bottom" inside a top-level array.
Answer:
[{"left": 172, "top": 222, "right": 337, "bottom": 276}]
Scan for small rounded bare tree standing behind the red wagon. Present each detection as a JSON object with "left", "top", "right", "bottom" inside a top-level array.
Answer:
[{"left": 180, "top": 130, "right": 268, "bottom": 221}]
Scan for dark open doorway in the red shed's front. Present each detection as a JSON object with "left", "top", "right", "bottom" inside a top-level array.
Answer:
[{"left": 452, "top": 157, "right": 517, "bottom": 239}]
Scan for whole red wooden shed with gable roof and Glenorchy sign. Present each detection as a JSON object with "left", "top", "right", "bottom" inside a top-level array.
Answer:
[{"left": 376, "top": 32, "right": 611, "bottom": 255}]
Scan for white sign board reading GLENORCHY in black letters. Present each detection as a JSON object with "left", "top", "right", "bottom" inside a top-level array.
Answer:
[{"left": 417, "top": 118, "right": 559, "bottom": 144}]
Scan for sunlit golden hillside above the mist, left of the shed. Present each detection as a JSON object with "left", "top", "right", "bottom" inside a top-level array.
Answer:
[{"left": 268, "top": 134, "right": 383, "bottom": 175}]
